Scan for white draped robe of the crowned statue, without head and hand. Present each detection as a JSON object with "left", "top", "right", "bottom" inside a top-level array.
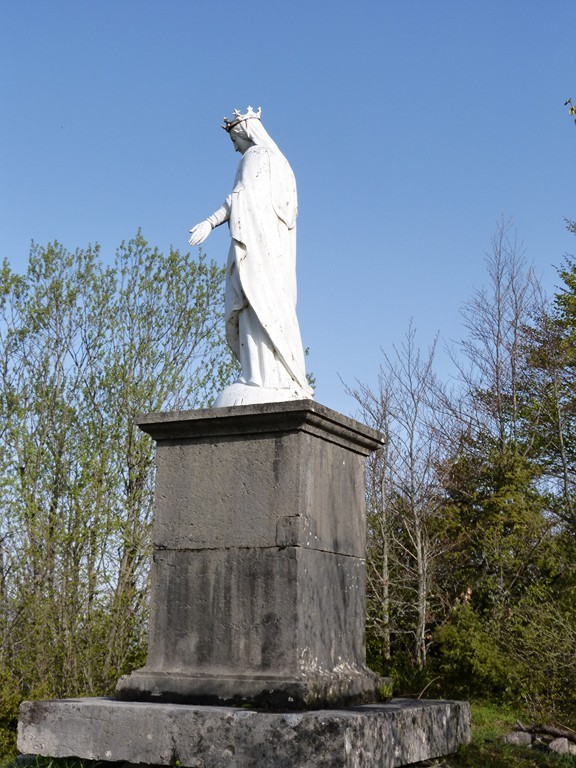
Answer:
[{"left": 223, "top": 146, "right": 312, "bottom": 397}]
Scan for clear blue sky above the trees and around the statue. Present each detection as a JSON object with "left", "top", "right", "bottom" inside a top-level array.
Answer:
[{"left": 0, "top": 0, "right": 576, "bottom": 413}]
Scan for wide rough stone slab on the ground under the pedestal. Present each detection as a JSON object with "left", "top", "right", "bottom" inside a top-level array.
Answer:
[{"left": 18, "top": 698, "right": 470, "bottom": 768}]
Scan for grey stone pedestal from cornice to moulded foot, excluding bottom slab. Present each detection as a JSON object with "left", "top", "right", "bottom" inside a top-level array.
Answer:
[{"left": 117, "top": 400, "right": 385, "bottom": 709}]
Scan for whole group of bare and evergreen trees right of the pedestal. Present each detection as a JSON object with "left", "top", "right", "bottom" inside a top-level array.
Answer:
[{"left": 362, "top": 222, "right": 576, "bottom": 722}]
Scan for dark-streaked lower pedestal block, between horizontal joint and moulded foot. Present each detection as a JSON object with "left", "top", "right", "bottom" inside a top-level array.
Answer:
[{"left": 148, "top": 547, "right": 364, "bottom": 675}]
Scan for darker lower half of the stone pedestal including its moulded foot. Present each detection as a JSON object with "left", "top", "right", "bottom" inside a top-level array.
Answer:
[{"left": 119, "top": 547, "right": 383, "bottom": 708}]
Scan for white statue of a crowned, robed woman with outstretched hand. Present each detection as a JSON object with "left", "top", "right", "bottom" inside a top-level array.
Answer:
[{"left": 189, "top": 107, "right": 312, "bottom": 406}]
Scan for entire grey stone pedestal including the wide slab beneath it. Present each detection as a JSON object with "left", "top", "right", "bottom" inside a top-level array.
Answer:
[{"left": 18, "top": 400, "right": 470, "bottom": 768}]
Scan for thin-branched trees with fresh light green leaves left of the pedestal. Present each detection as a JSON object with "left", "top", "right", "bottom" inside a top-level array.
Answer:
[{"left": 0, "top": 234, "right": 233, "bottom": 732}]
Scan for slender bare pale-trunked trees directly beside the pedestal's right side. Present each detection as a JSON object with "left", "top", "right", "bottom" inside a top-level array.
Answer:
[{"left": 349, "top": 325, "right": 452, "bottom": 671}]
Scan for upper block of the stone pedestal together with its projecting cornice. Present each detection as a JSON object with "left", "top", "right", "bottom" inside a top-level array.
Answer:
[{"left": 148, "top": 401, "right": 374, "bottom": 557}]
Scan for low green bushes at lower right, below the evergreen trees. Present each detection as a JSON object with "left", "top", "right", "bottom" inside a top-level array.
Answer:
[{"left": 430, "top": 544, "right": 576, "bottom": 721}]
